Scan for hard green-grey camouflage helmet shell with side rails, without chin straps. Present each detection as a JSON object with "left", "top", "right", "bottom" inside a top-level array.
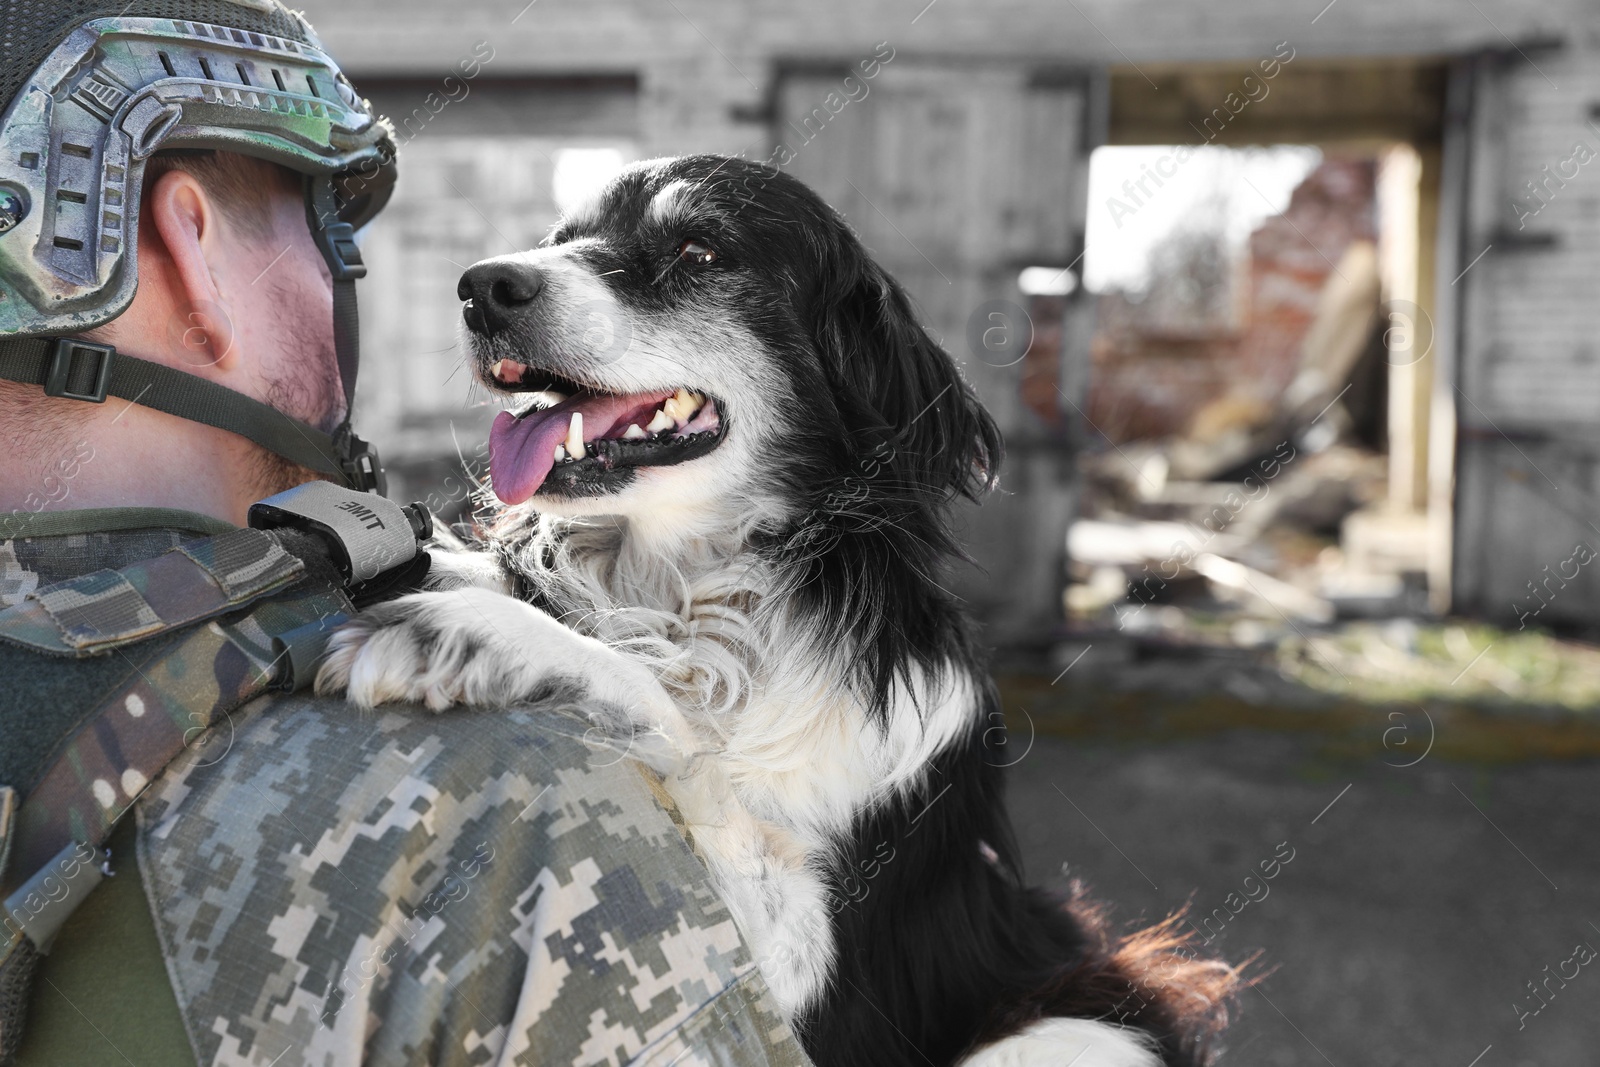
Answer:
[{"left": 0, "top": 0, "right": 395, "bottom": 336}]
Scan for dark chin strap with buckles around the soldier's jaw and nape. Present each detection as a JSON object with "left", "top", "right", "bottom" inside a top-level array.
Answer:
[{"left": 0, "top": 176, "right": 387, "bottom": 496}]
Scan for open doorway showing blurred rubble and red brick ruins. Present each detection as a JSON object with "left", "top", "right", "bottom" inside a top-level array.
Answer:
[{"left": 1066, "top": 58, "right": 1450, "bottom": 633}]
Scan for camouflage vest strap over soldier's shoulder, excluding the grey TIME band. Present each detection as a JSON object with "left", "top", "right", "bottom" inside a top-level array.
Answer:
[{"left": 0, "top": 530, "right": 354, "bottom": 1064}]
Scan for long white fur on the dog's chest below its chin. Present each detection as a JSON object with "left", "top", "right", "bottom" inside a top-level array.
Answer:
[{"left": 409, "top": 530, "right": 979, "bottom": 1016}]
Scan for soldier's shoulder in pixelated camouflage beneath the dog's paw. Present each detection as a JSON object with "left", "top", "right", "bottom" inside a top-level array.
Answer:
[{"left": 0, "top": 511, "right": 805, "bottom": 1067}]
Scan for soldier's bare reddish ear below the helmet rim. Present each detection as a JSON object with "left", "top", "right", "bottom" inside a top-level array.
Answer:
[{"left": 141, "top": 171, "right": 238, "bottom": 371}]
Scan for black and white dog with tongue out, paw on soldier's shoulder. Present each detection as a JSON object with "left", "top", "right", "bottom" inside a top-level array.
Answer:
[{"left": 320, "top": 155, "right": 1238, "bottom": 1067}]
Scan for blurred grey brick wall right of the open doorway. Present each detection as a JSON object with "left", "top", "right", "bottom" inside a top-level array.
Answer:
[{"left": 1454, "top": 35, "right": 1600, "bottom": 627}]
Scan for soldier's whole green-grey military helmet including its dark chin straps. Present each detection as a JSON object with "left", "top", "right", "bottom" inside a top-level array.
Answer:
[{"left": 0, "top": 0, "right": 395, "bottom": 488}]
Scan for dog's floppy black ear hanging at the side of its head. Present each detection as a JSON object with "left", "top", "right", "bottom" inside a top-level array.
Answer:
[{"left": 816, "top": 251, "right": 1003, "bottom": 499}]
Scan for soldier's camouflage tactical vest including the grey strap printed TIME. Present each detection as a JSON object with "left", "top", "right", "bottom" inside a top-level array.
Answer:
[{"left": 0, "top": 482, "right": 432, "bottom": 1067}]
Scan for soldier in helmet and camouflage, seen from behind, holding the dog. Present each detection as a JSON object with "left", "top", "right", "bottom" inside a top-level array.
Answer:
[{"left": 0, "top": 0, "right": 805, "bottom": 1067}]
